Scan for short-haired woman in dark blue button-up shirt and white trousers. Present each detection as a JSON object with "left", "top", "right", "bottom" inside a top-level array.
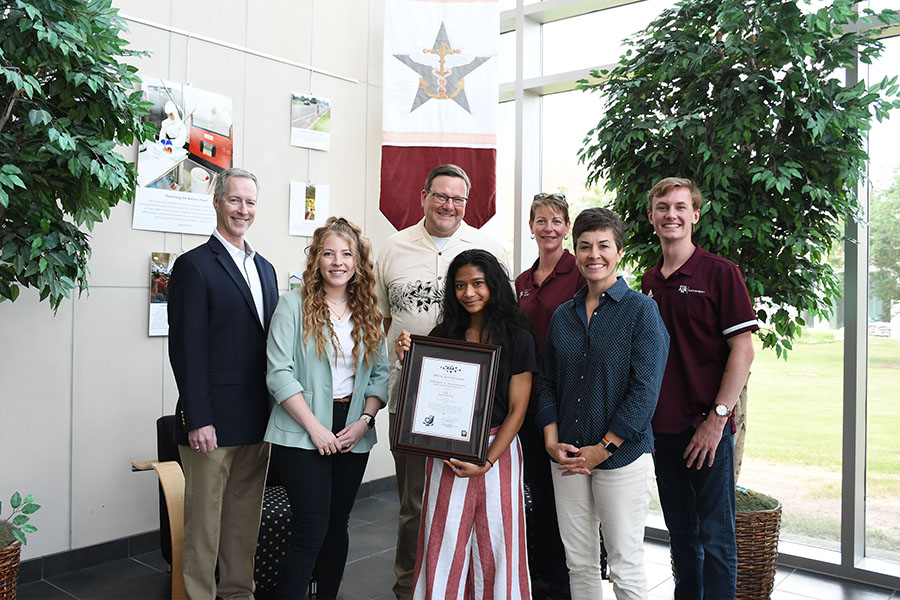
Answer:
[{"left": 535, "top": 208, "right": 669, "bottom": 600}]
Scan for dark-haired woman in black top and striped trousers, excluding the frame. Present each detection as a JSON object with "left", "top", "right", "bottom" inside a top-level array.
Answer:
[{"left": 397, "top": 249, "right": 535, "bottom": 600}]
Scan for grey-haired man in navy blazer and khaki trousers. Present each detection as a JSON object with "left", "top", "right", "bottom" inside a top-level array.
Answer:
[{"left": 168, "top": 169, "right": 278, "bottom": 600}]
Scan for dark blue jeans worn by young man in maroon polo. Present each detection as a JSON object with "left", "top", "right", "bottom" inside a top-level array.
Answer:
[{"left": 654, "top": 425, "right": 737, "bottom": 600}]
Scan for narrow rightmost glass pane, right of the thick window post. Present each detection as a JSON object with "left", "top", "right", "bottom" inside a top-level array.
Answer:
[{"left": 866, "top": 37, "right": 900, "bottom": 573}]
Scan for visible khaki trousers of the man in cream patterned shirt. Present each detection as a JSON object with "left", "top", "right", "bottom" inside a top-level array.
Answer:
[{"left": 390, "top": 413, "right": 426, "bottom": 600}]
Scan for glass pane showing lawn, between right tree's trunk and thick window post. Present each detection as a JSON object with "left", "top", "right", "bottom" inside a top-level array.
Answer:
[{"left": 740, "top": 330, "right": 844, "bottom": 551}]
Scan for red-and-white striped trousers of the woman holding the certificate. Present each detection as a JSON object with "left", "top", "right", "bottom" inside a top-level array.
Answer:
[{"left": 413, "top": 435, "right": 531, "bottom": 600}]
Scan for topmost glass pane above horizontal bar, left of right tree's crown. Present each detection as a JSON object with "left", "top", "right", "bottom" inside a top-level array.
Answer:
[{"left": 543, "top": 0, "right": 675, "bottom": 75}]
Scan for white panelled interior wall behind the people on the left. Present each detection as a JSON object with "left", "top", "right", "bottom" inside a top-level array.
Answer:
[{"left": 0, "top": 0, "right": 394, "bottom": 559}]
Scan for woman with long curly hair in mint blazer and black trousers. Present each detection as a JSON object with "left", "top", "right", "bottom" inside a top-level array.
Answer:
[{"left": 265, "top": 217, "right": 389, "bottom": 598}]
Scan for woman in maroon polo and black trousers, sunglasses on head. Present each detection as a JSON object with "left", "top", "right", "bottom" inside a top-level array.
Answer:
[{"left": 516, "top": 194, "right": 585, "bottom": 598}]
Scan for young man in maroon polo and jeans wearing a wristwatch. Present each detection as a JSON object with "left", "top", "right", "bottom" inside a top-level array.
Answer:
[{"left": 641, "top": 177, "right": 759, "bottom": 599}]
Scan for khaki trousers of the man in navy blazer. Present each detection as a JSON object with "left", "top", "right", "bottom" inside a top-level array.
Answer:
[{"left": 178, "top": 442, "right": 269, "bottom": 600}]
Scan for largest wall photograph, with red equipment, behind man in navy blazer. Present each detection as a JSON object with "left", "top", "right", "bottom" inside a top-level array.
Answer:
[{"left": 132, "top": 77, "right": 234, "bottom": 234}]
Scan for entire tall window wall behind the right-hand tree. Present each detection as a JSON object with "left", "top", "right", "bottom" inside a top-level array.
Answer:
[{"left": 498, "top": 0, "right": 900, "bottom": 587}]
